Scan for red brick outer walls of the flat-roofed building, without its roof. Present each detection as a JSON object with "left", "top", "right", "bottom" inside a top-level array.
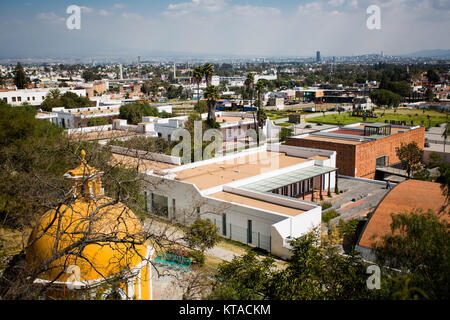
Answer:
[{"left": 286, "top": 127, "right": 425, "bottom": 179}]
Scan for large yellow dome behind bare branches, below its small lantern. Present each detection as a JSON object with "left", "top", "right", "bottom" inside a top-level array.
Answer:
[{"left": 26, "top": 196, "right": 147, "bottom": 282}]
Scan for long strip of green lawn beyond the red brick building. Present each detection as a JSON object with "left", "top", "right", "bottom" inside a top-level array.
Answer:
[{"left": 307, "top": 109, "right": 447, "bottom": 127}]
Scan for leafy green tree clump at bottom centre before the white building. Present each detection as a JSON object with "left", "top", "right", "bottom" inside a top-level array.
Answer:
[{"left": 209, "top": 232, "right": 377, "bottom": 300}]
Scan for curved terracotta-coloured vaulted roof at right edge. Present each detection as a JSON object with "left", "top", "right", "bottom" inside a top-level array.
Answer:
[{"left": 358, "top": 180, "right": 449, "bottom": 248}]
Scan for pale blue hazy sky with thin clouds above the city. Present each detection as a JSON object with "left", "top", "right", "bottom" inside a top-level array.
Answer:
[{"left": 0, "top": 0, "right": 450, "bottom": 58}]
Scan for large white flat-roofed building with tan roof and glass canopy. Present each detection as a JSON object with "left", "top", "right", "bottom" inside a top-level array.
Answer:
[{"left": 144, "top": 144, "right": 337, "bottom": 258}]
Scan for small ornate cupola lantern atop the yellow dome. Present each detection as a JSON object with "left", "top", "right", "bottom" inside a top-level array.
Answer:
[{"left": 64, "top": 150, "right": 103, "bottom": 201}]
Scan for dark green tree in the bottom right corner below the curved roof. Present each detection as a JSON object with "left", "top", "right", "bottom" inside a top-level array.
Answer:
[{"left": 376, "top": 209, "right": 450, "bottom": 300}]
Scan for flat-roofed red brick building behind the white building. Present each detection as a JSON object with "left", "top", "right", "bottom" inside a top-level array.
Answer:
[{"left": 286, "top": 127, "right": 425, "bottom": 179}]
